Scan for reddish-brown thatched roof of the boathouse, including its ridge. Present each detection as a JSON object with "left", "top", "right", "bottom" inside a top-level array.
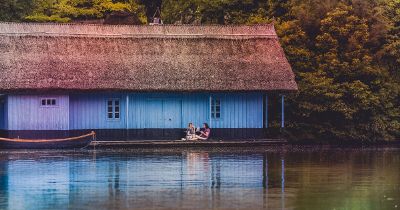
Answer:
[{"left": 0, "top": 23, "right": 297, "bottom": 92}]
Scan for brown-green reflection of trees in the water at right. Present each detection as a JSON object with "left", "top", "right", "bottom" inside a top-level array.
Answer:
[{"left": 287, "top": 149, "right": 400, "bottom": 209}]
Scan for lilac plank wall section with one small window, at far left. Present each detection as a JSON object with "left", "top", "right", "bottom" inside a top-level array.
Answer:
[{"left": 7, "top": 95, "right": 69, "bottom": 130}]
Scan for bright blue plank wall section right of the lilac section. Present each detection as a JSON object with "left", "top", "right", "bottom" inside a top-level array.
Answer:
[{"left": 69, "top": 93, "right": 263, "bottom": 130}]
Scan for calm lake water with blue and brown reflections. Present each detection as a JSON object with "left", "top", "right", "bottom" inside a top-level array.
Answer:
[{"left": 0, "top": 147, "right": 400, "bottom": 210}]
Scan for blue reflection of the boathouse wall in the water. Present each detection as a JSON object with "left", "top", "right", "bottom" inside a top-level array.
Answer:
[{"left": 0, "top": 151, "right": 285, "bottom": 209}]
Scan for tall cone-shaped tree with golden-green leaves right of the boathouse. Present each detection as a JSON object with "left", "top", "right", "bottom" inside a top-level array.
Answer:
[{"left": 303, "top": 3, "right": 398, "bottom": 140}]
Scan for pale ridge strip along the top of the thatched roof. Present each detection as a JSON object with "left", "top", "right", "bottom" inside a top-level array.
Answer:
[{"left": 0, "top": 22, "right": 276, "bottom": 37}]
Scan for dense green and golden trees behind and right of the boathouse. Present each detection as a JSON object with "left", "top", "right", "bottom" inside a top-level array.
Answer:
[{"left": 0, "top": 0, "right": 400, "bottom": 141}]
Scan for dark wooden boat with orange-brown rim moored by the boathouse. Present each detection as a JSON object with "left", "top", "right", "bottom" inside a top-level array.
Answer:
[{"left": 0, "top": 131, "right": 96, "bottom": 149}]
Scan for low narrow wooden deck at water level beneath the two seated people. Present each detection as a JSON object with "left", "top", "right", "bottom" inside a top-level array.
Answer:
[{"left": 90, "top": 139, "right": 287, "bottom": 148}]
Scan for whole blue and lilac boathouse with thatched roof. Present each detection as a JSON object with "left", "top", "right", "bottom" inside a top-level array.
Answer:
[{"left": 0, "top": 23, "right": 297, "bottom": 140}]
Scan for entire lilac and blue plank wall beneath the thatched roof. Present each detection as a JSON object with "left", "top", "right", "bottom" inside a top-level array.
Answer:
[{"left": 0, "top": 93, "right": 263, "bottom": 131}]
